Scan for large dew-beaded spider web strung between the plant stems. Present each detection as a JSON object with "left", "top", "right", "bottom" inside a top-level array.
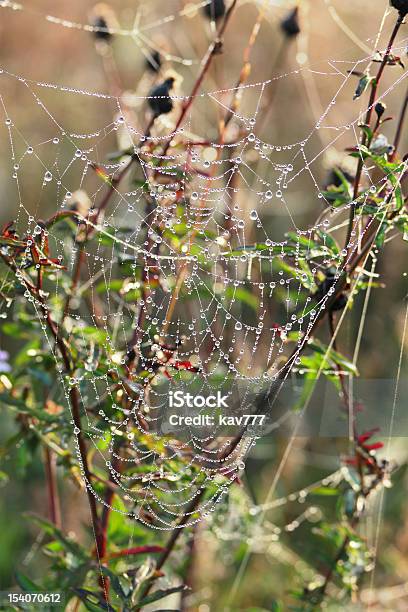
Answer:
[{"left": 0, "top": 2, "right": 406, "bottom": 592}]
